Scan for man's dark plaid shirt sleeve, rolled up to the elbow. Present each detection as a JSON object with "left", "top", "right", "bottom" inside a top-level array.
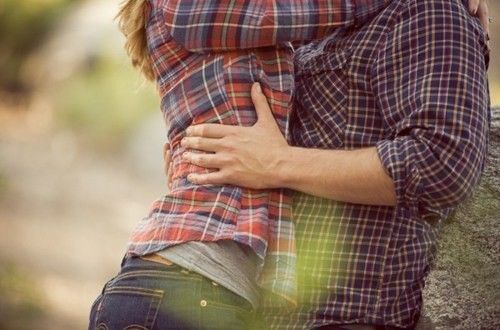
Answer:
[{"left": 372, "top": 0, "right": 490, "bottom": 218}]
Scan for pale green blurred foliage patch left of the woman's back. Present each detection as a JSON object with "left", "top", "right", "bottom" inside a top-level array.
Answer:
[{"left": 56, "top": 57, "right": 159, "bottom": 151}]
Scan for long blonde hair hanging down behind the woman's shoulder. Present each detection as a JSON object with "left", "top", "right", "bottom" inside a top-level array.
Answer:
[{"left": 116, "top": 0, "right": 155, "bottom": 80}]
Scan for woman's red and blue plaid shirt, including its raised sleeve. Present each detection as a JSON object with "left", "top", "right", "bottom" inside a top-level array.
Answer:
[{"left": 124, "top": 0, "right": 384, "bottom": 301}]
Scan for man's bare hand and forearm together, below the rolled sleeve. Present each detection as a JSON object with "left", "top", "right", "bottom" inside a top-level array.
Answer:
[{"left": 182, "top": 84, "right": 396, "bottom": 205}]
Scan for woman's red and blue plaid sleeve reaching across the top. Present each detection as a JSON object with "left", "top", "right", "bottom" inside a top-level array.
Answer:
[{"left": 161, "top": 0, "right": 390, "bottom": 51}]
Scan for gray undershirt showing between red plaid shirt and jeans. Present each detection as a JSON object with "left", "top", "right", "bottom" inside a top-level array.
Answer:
[{"left": 157, "top": 240, "right": 259, "bottom": 309}]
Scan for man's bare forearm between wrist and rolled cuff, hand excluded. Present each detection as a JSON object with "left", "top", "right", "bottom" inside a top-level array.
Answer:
[{"left": 276, "top": 147, "right": 396, "bottom": 206}]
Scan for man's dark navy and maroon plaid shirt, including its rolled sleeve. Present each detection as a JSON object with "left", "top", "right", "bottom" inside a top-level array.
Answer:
[{"left": 264, "top": 0, "right": 490, "bottom": 329}]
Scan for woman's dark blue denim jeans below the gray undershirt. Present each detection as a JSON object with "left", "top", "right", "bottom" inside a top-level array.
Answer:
[{"left": 89, "top": 258, "right": 255, "bottom": 330}]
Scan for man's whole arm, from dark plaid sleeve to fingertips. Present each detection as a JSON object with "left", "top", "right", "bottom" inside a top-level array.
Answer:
[{"left": 179, "top": 0, "right": 489, "bottom": 208}]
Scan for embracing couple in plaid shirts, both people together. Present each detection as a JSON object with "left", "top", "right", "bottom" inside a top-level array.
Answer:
[{"left": 89, "top": 0, "right": 490, "bottom": 330}]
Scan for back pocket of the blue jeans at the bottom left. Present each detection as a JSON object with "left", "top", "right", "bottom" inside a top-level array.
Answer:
[{"left": 91, "top": 286, "right": 164, "bottom": 330}]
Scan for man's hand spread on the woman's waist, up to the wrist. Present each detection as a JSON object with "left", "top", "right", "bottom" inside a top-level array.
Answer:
[{"left": 181, "top": 83, "right": 290, "bottom": 189}]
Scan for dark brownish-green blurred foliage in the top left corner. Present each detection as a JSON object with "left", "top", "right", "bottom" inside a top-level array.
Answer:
[{"left": 0, "top": 0, "right": 78, "bottom": 92}]
